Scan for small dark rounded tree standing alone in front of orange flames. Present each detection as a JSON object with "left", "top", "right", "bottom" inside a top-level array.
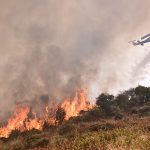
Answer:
[{"left": 55, "top": 106, "right": 66, "bottom": 125}]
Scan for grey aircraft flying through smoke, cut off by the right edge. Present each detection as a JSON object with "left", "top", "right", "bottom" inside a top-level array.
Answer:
[{"left": 129, "top": 33, "right": 150, "bottom": 46}]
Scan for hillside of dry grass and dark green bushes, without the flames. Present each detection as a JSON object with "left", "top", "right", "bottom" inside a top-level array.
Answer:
[{"left": 0, "top": 86, "right": 150, "bottom": 150}]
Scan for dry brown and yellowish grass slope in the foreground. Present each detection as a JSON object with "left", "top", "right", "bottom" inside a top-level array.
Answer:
[{"left": 0, "top": 118, "right": 150, "bottom": 150}]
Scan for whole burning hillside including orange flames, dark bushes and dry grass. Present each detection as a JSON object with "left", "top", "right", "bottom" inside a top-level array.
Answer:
[{"left": 0, "top": 86, "right": 150, "bottom": 150}]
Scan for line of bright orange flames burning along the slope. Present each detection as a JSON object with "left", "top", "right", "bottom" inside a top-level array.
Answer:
[{"left": 0, "top": 90, "right": 91, "bottom": 138}]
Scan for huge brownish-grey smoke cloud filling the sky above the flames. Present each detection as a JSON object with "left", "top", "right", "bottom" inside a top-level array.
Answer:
[{"left": 0, "top": 0, "right": 150, "bottom": 116}]
